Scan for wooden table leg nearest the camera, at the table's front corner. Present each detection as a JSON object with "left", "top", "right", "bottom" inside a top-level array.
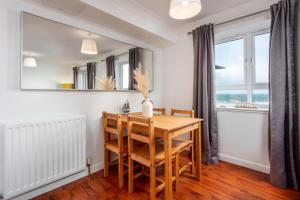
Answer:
[{"left": 164, "top": 132, "right": 172, "bottom": 200}]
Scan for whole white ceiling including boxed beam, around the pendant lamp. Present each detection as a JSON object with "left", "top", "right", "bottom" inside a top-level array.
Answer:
[{"left": 22, "top": 0, "right": 271, "bottom": 47}]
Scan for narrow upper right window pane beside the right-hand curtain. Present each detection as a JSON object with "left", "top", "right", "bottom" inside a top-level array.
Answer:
[{"left": 254, "top": 33, "right": 270, "bottom": 83}]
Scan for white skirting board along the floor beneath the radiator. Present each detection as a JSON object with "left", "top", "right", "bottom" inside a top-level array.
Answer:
[{"left": 9, "top": 162, "right": 104, "bottom": 200}]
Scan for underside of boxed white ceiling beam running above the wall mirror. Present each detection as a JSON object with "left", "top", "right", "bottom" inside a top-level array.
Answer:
[{"left": 22, "top": 0, "right": 178, "bottom": 47}]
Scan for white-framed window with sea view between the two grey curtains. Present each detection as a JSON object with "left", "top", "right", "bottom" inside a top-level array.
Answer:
[{"left": 215, "top": 31, "right": 270, "bottom": 107}]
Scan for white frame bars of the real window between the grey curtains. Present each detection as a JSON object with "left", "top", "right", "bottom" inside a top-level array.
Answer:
[{"left": 215, "top": 28, "right": 270, "bottom": 108}]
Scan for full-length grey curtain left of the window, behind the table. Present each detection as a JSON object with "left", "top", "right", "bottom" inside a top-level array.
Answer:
[{"left": 193, "top": 24, "right": 219, "bottom": 164}]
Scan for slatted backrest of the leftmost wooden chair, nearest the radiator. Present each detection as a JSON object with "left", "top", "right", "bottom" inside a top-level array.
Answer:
[{"left": 102, "top": 112, "right": 123, "bottom": 150}]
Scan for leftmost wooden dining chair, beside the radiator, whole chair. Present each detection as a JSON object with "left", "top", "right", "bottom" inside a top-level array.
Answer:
[{"left": 102, "top": 112, "right": 128, "bottom": 188}]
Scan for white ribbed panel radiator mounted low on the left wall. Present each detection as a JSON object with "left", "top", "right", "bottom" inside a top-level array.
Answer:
[{"left": 0, "top": 115, "right": 86, "bottom": 199}]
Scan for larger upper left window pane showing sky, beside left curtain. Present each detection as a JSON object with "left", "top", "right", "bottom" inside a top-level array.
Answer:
[{"left": 215, "top": 39, "right": 245, "bottom": 86}]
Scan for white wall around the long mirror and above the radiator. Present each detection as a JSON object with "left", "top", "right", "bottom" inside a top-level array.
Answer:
[{"left": 0, "top": 0, "right": 162, "bottom": 176}]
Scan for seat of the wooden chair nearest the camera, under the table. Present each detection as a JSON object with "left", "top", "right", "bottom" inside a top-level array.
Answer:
[{"left": 131, "top": 140, "right": 190, "bottom": 166}]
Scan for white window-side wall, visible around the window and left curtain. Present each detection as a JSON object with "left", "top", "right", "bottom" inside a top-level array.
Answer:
[{"left": 163, "top": 14, "right": 269, "bottom": 173}]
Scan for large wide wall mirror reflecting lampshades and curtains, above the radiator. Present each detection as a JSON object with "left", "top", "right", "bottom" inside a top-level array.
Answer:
[{"left": 21, "top": 13, "right": 153, "bottom": 91}]
